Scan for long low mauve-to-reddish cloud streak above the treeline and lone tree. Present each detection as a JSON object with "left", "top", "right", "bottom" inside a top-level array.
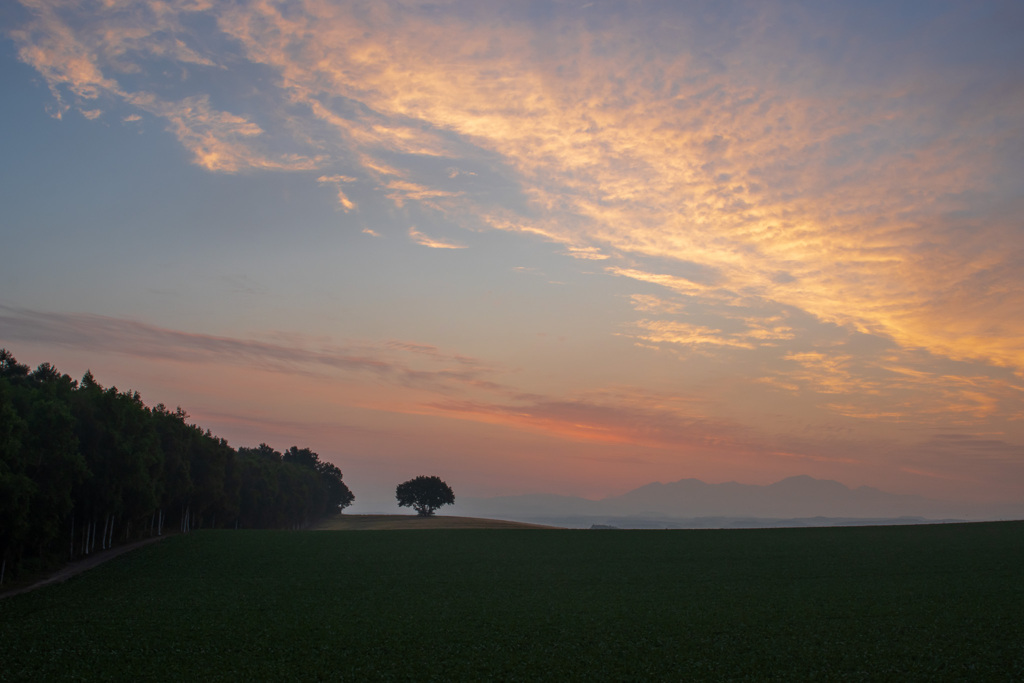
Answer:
[{"left": 0, "top": 306, "right": 753, "bottom": 449}]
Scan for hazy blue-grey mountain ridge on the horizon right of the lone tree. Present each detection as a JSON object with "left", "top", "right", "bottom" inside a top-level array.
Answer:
[{"left": 453, "top": 475, "right": 1024, "bottom": 528}]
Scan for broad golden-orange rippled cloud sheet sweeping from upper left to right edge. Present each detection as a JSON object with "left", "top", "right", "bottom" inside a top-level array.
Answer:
[{"left": 10, "top": 0, "right": 1024, "bottom": 376}]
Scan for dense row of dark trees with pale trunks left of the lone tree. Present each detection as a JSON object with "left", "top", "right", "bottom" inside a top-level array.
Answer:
[{"left": 0, "top": 349, "right": 354, "bottom": 582}]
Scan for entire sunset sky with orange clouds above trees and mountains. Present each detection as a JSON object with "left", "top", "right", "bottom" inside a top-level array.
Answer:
[{"left": 0, "top": 0, "right": 1024, "bottom": 511}]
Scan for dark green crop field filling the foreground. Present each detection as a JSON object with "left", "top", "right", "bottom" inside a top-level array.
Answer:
[{"left": 0, "top": 522, "right": 1024, "bottom": 681}]
